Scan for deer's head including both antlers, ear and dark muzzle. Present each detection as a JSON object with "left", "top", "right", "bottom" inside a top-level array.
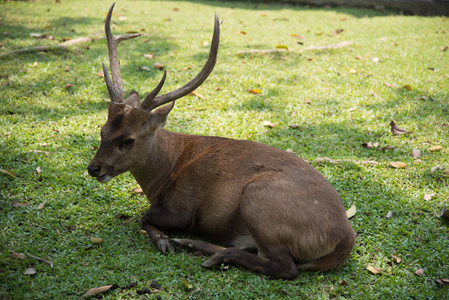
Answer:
[{"left": 87, "top": 3, "right": 220, "bottom": 182}]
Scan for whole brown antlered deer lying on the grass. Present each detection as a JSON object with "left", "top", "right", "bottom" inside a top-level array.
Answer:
[{"left": 88, "top": 4, "right": 355, "bottom": 279}]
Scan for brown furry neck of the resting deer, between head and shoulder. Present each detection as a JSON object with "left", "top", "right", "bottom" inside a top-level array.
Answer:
[{"left": 130, "top": 129, "right": 182, "bottom": 203}]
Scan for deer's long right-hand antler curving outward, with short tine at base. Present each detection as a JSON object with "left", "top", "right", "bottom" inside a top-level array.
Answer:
[{"left": 140, "top": 13, "right": 220, "bottom": 111}]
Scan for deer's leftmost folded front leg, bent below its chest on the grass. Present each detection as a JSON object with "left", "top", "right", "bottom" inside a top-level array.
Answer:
[{"left": 141, "top": 206, "right": 188, "bottom": 253}]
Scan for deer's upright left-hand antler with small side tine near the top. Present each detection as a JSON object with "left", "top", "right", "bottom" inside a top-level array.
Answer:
[{"left": 103, "top": 2, "right": 140, "bottom": 103}]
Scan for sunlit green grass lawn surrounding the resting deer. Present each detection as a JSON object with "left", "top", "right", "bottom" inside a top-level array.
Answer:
[{"left": 0, "top": 1, "right": 449, "bottom": 299}]
